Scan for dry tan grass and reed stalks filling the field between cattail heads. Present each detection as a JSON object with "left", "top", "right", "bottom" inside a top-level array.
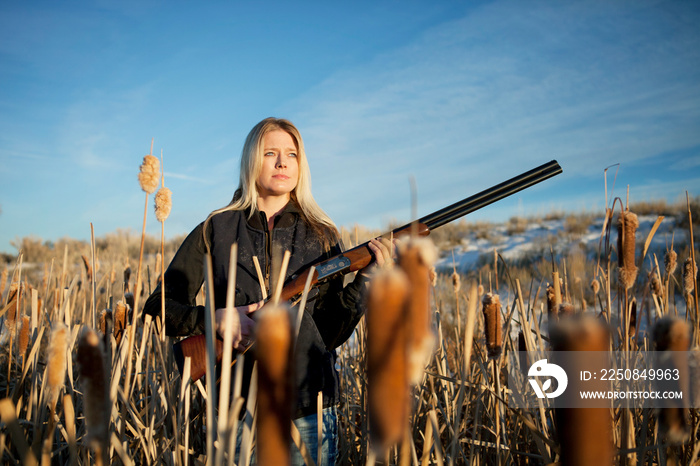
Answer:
[{"left": 0, "top": 174, "right": 700, "bottom": 466}]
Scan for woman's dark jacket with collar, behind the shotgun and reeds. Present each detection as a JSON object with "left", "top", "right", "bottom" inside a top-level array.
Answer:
[{"left": 145, "top": 201, "right": 364, "bottom": 417}]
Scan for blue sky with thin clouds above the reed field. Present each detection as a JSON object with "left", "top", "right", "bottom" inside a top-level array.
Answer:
[{"left": 0, "top": 1, "right": 700, "bottom": 253}]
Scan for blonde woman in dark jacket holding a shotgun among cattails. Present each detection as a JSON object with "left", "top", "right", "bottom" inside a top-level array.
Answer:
[{"left": 145, "top": 118, "right": 390, "bottom": 464}]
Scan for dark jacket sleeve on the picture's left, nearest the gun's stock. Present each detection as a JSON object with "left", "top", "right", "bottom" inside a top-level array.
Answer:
[{"left": 144, "top": 224, "right": 206, "bottom": 336}]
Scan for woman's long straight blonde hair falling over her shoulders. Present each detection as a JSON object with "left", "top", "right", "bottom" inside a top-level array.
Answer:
[{"left": 203, "top": 117, "right": 339, "bottom": 250}]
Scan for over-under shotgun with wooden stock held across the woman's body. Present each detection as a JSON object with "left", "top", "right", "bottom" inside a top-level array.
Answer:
[{"left": 173, "top": 160, "right": 562, "bottom": 381}]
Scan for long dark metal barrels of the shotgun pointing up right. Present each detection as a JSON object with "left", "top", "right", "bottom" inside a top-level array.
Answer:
[{"left": 418, "top": 160, "right": 562, "bottom": 230}]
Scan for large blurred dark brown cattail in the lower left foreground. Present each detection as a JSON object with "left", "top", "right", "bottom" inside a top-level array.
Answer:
[{"left": 77, "top": 329, "right": 110, "bottom": 459}]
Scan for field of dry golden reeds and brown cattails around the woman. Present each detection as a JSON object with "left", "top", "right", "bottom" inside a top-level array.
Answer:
[{"left": 0, "top": 155, "right": 700, "bottom": 466}]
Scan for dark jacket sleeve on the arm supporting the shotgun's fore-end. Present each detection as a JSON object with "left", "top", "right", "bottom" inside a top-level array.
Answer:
[{"left": 313, "top": 246, "right": 367, "bottom": 350}]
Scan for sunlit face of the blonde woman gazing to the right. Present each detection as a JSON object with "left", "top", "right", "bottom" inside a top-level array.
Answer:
[{"left": 257, "top": 129, "right": 299, "bottom": 199}]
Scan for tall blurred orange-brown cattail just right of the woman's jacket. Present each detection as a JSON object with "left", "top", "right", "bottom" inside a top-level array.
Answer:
[{"left": 366, "top": 268, "right": 410, "bottom": 452}]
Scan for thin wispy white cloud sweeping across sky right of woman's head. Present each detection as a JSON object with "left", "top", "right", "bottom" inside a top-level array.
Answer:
[{"left": 289, "top": 2, "right": 700, "bottom": 226}]
